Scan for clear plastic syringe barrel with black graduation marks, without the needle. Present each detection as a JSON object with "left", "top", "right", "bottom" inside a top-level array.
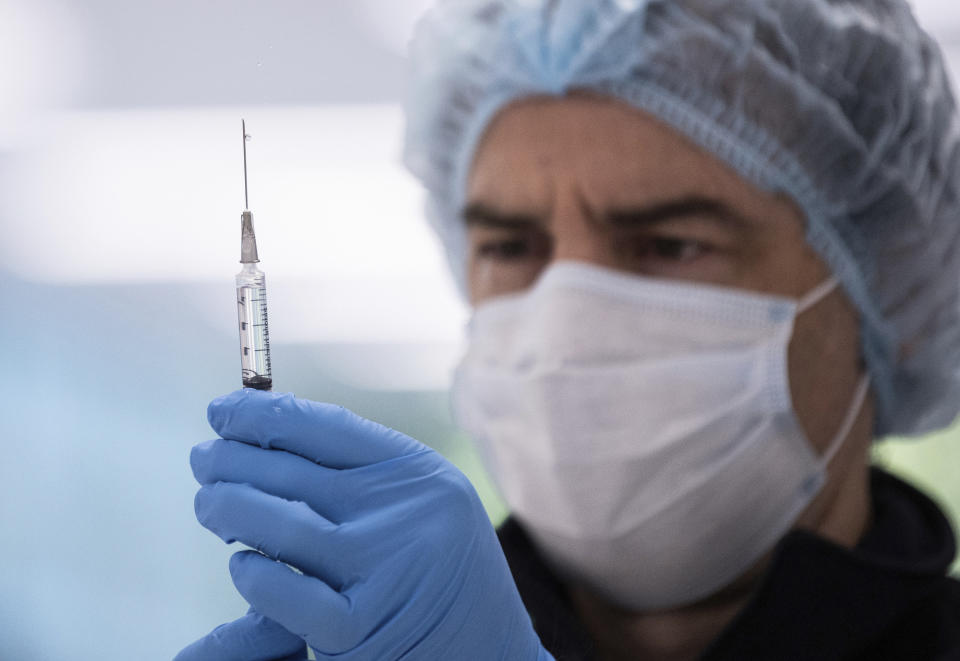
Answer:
[{"left": 237, "top": 264, "right": 273, "bottom": 390}]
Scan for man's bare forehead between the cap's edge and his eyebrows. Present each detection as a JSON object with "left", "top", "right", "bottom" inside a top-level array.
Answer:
[{"left": 465, "top": 97, "right": 765, "bottom": 215}]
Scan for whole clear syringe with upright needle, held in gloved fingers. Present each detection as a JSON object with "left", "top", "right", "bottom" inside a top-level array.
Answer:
[{"left": 237, "top": 120, "right": 273, "bottom": 390}]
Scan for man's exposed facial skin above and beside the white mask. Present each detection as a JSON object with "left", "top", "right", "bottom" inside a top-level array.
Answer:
[{"left": 464, "top": 95, "right": 870, "bottom": 532}]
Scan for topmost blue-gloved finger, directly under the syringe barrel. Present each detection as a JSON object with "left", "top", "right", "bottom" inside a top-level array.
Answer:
[{"left": 207, "top": 388, "right": 424, "bottom": 468}]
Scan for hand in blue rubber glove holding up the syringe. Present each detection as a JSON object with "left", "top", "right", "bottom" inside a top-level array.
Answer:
[{"left": 177, "top": 390, "right": 553, "bottom": 661}]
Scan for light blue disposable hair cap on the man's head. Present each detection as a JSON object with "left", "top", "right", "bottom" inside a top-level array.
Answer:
[{"left": 405, "top": 0, "right": 960, "bottom": 435}]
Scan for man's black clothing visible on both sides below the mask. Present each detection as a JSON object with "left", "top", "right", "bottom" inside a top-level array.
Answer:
[{"left": 498, "top": 470, "right": 960, "bottom": 661}]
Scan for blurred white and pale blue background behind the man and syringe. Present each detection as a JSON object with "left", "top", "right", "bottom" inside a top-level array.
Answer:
[{"left": 0, "top": 0, "right": 960, "bottom": 661}]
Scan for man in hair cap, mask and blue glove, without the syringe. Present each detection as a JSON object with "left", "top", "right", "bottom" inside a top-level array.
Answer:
[{"left": 179, "top": 0, "right": 960, "bottom": 661}]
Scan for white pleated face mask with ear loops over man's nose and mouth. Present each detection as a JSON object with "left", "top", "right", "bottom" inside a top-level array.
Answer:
[{"left": 453, "top": 262, "right": 868, "bottom": 610}]
